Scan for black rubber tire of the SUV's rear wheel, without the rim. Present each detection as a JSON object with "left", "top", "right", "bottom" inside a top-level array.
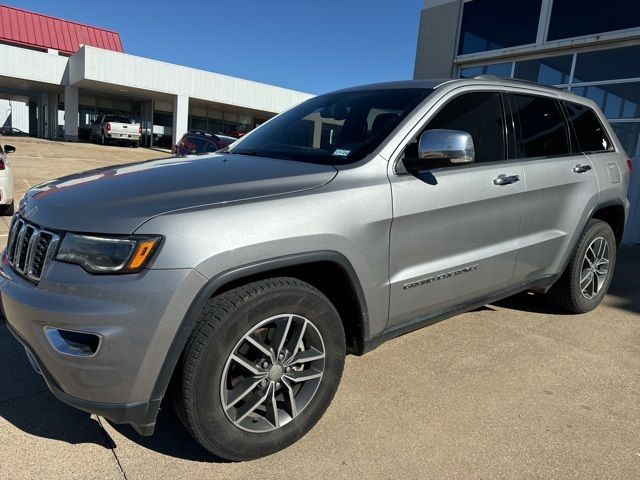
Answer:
[{"left": 547, "top": 219, "right": 617, "bottom": 313}]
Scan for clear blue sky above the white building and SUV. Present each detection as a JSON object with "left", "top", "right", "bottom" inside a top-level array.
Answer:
[{"left": 3, "top": 0, "right": 423, "bottom": 93}]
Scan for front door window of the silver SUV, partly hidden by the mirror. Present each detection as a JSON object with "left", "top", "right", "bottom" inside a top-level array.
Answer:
[{"left": 405, "top": 92, "right": 505, "bottom": 163}]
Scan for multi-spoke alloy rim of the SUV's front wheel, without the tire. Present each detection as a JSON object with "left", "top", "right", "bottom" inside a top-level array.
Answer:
[{"left": 220, "top": 314, "right": 325, "bottom": 433}]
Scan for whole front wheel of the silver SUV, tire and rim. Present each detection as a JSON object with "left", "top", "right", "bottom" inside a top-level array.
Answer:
[{"left": 175, "top": 278, "right": 345, "bottom": 461}]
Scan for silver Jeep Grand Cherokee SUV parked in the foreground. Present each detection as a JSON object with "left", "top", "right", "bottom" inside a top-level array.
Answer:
[{"left": 0, "top": 77, "right": 631, "bottom": 460}]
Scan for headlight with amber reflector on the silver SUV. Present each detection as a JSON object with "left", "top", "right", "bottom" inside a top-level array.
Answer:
[{"left": 56, "top": 233, "right": 160, "bottom": 273}]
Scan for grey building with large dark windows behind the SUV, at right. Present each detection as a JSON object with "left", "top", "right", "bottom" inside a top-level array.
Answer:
[{"left": 414, "top": 0, "right": 640, "bottom": 243}]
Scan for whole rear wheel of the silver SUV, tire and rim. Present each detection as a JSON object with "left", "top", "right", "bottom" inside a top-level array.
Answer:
[{"left": 549, "top": 219, "right": 616, "bottom": 313}]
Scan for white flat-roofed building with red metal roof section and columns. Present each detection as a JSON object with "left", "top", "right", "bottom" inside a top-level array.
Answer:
[{"left": 0, "top": 5, "right": 311, "bottom": 147}]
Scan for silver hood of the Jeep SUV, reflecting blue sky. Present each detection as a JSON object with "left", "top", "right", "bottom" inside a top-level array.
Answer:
[{"left": 19, "top": 154, "right": 337, "bottom": 234}]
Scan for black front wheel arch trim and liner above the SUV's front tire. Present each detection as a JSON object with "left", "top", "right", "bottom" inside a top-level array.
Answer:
[{"left": 151, "top": 250, "right": 369, "bottom": 403}]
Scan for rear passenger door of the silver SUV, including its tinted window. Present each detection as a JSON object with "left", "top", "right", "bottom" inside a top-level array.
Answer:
[{"left": 509, "top": 93, "right": 598, "bottom": 281}]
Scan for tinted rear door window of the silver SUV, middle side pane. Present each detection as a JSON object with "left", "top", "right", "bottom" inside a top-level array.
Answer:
[{"left": 511, "top": 95, "right": 569, "bottom": 158}]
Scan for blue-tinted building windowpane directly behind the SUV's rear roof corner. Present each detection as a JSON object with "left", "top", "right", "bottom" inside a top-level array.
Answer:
[{"left": 571, "top": 82, "right": 640, "bottom": 118}]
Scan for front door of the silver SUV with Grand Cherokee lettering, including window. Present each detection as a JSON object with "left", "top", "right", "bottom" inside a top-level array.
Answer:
[{"left": 389, "top": 91, "right": 524, "bottom": 328}]
